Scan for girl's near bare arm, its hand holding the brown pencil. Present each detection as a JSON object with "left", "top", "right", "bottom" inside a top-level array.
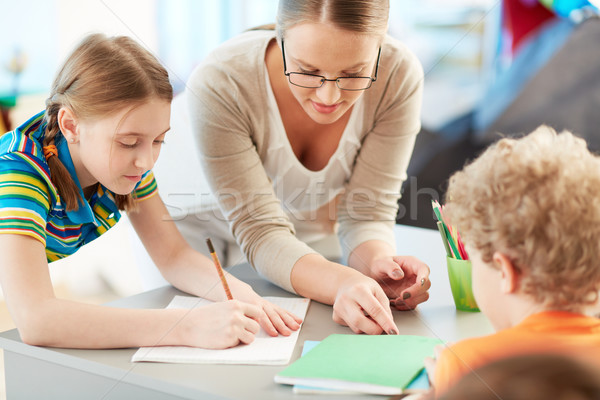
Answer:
[{"left": 0, "top": 234, "right": 262, "bottom": 348}]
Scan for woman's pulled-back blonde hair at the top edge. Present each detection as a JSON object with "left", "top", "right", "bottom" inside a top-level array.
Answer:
[{"left": 276, "top": 0, "right": 390, "bottom": 39}]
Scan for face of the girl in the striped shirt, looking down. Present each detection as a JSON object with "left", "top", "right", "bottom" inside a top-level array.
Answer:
[{"left": 69, "top": 99, "right": 171, "bottom": 195}]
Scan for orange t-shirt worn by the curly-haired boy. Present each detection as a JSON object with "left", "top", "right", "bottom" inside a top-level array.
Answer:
[{"left": 433, "top": 311, "right": 600, "bottom": 396}]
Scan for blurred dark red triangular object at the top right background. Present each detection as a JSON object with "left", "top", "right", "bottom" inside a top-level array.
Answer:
[{"left": 502, "top": 0, "right": 557, "bottom": 53}]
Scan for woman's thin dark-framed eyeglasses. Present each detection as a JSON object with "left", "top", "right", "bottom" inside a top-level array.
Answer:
[{"left": 281, "top": 38, "right": 381, "bottom": 90}]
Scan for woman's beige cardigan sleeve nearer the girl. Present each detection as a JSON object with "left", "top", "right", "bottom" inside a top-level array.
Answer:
[{"left": 187, "top": 46, "right": 316, "bottom": 292}]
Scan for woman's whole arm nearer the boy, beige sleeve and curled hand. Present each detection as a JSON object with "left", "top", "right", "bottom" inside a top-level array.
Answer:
[{"left": 338, "top": 39, "right": 430, "bottom": 309}]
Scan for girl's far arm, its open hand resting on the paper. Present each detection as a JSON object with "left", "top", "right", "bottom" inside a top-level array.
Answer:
[{"left": 128, "top": 195, "right": 302, "bottom": 336}]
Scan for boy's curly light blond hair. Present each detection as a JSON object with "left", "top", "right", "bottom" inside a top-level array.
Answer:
[{"left": 446, "top": 126, "right": 600, "bottom": 311}]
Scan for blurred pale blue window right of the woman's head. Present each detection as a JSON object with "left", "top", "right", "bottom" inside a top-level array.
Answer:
[{"left": 389, "top": 0, "right": 500, "bottom": 131}]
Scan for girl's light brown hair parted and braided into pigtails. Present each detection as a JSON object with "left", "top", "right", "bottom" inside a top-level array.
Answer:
[{"left": 43, "top": 34, "right": 173, "bottom": 210}]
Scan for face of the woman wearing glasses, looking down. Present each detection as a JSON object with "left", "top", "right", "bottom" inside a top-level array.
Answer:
[{"left": 283, "top": 23, "right": 380, "bottom": 124}]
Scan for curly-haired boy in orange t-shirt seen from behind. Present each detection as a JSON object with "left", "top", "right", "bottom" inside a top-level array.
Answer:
[{"left": 426, "top": 126, "right": 600, "bottom": 396}]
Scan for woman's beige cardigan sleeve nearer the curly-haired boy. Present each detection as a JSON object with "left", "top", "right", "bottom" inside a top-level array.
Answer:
[{"left": 338, "top": 39, "right": 423, "bottom": 259}]
